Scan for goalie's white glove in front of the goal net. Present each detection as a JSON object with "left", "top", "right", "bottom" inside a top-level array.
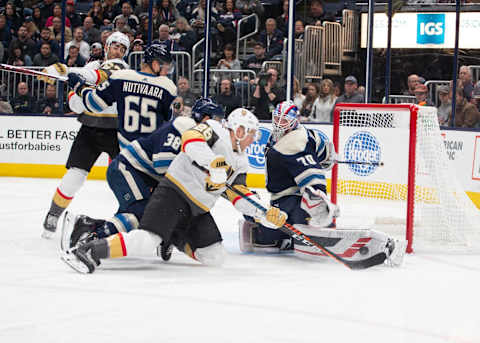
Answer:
[{"left": 300, "top": 186, "right": 340, "bottom": 227}]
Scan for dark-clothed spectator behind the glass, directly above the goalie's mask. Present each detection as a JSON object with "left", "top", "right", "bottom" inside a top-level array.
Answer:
[{"left": 252, "top": 68, "right": 285, "bottom": 120}]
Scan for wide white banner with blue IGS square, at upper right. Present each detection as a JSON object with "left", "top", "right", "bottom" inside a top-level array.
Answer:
[{"left": 360, "top": 12, "right": 480, "bottom": 49}]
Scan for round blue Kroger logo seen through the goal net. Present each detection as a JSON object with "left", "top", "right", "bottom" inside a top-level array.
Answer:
[{"left": 344, "top": 131, "right": 381, "bottom": 176}]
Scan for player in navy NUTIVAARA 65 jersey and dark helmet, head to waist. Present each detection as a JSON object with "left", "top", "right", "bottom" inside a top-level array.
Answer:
[{"left": 68, "top": 44, "right": 177, "bottom": 148}]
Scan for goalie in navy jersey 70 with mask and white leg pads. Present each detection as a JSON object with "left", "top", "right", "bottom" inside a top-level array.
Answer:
[{"left": 239, "top": 101, "right": 405, "bottom": 266}]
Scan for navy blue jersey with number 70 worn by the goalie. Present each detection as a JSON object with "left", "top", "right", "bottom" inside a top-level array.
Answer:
[{"left": 265, "top": 126, "right": 327, "bottom": 201}]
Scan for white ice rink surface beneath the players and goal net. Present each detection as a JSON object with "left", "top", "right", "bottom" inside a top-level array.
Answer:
[{"left": 0, "top": 178, "right": 480, "bottom": 343}]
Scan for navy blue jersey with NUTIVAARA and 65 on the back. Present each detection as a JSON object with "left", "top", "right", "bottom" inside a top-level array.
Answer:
[{"left": 82, "top": 70, "right": 177, "bottom": 148}]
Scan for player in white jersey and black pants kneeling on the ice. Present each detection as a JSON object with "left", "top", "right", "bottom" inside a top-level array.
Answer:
[{"left": 62, "top": 105, "right": 287, "bottom": 273}]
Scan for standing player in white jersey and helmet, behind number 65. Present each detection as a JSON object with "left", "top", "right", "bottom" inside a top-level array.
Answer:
[{"left": 42, "top": 32, "right": 130, "bottom": 238}]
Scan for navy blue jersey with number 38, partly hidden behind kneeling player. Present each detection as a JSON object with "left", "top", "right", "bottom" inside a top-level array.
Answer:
[{"left": 118, "top": 117, "right": 196, "bottom": 181}]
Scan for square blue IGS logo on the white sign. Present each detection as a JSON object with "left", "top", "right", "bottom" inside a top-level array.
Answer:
[{"left": 417, "top": 13, "right": 445, "bottom": 44}]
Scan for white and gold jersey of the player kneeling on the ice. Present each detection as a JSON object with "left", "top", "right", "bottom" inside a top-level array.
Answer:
[{"left": 165, "top": 120, "right": 251, "bottom": 215}]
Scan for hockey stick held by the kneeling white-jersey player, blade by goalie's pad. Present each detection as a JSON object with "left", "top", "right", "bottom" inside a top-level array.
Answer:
[{"left": 192, "top": 161, "right": 386, "bottom": 270}]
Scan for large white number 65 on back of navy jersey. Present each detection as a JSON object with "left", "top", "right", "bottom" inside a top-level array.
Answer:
[{"left": 123, "top": 95, "right": 158, "bottom": 133}]
